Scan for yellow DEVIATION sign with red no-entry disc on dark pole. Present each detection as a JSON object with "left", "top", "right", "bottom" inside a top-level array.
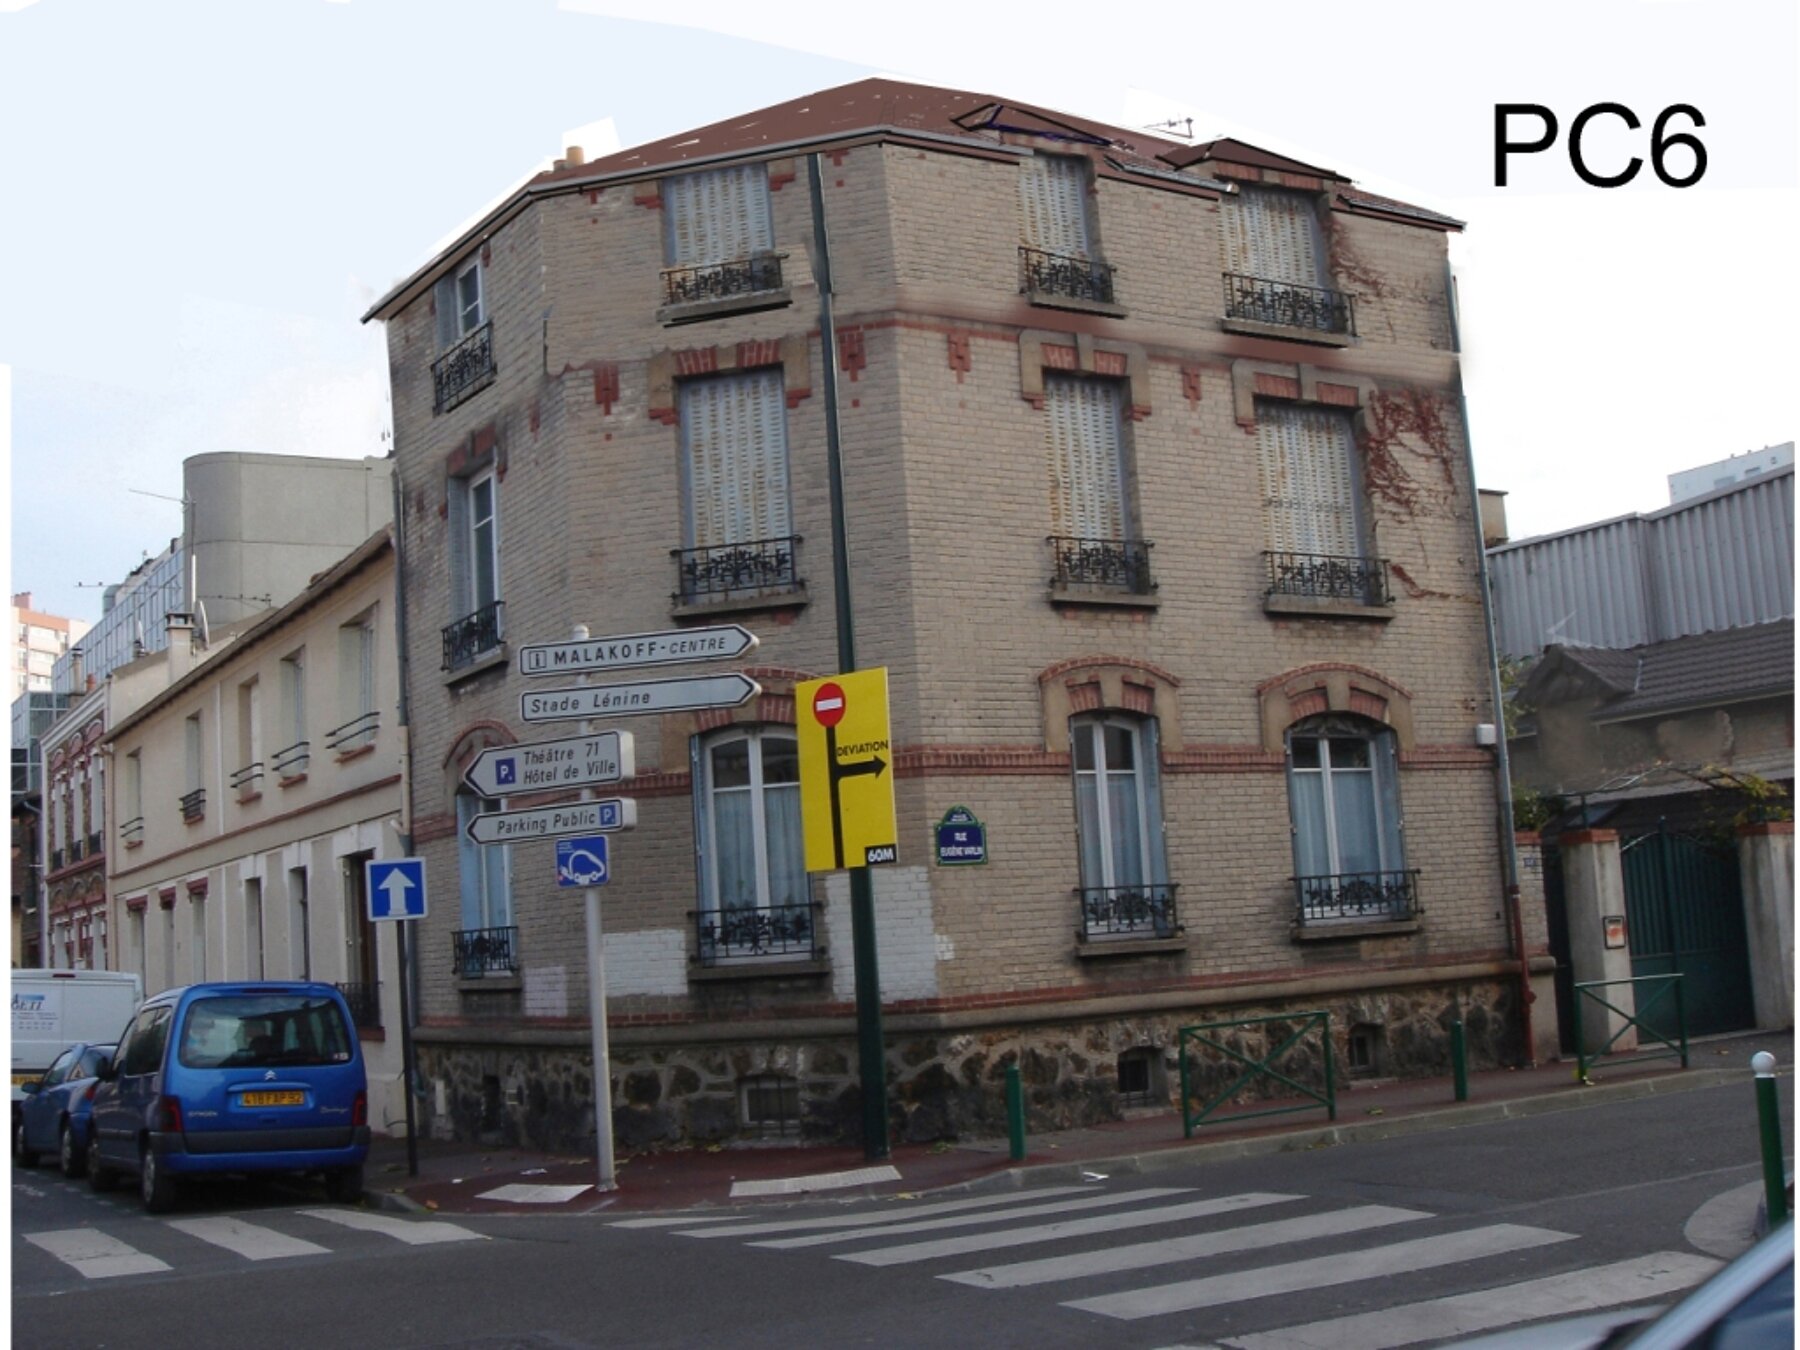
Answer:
[{"left": 794, "top": 666, "right": 900, "bottom": 871}]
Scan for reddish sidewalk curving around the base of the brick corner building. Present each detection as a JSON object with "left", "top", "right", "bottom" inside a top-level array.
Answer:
[{"left": 365, "top": 1031, "right": 1795, "bottom": 1213}]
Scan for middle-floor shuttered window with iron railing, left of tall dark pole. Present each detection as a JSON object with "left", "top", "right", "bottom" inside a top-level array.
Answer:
[{"left": 680, "top": 367, "right": 799, "bottom": 603}]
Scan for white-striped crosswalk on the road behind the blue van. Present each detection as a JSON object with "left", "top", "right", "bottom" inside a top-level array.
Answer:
[{"left": 14, "top": 1210, "right": 486, "bottom": 1280}]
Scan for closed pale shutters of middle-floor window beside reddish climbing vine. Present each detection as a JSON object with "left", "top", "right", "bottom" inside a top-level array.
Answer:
[{"left": 1256, "top": 403, "right": 1363, "bottom": 556}]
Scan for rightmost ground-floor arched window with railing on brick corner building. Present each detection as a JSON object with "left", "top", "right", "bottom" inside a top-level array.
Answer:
[{"left": 1287, "top": 715, "right": 1417, "bottom": 923}]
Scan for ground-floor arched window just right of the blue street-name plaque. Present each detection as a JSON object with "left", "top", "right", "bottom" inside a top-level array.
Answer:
[{"left": 1069, "top": 713, "right": 1175, "bottom": 938}]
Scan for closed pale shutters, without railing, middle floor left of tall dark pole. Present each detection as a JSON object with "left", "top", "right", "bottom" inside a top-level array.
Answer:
[{"left": 680, "top": 369, "right": 794, "bottom": 549}]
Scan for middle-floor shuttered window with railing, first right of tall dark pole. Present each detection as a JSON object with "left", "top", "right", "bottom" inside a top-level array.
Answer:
[{"left": 1044, "top": 374, "right": 1154, "bottom": 594}]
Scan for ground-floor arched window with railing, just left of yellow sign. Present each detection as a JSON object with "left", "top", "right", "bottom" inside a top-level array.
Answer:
[{"left": 695, "top": 727, "right": 817, "bottom": 965}]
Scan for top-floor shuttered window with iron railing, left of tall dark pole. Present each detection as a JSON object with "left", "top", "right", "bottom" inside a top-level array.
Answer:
[{"left": 662, "top": 164, "right": 781, "bottom": 306}]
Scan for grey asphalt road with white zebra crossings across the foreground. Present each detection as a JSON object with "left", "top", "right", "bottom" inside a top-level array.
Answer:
[{"left": 11, "top": 1082, "right": 1791, "bottom": 1350}]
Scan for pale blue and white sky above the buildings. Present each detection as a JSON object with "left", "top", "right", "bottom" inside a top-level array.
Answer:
[{"left": 0, "top": 0, "right": 1800, "bottom": 619}]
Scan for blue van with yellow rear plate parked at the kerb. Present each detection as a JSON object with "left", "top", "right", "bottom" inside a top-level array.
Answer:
[{"left": 88, "top": 981, "right": 369, "bottom": 1213}]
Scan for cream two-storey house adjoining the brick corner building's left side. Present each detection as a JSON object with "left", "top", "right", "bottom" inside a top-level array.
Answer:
[{"left": 103, "top": 527, "right": 405, "bottom": 1129}]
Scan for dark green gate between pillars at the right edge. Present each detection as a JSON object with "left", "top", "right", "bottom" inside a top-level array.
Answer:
[{"left": 1620, "top": 828, "right": 1755, "bottom": 1039}]
